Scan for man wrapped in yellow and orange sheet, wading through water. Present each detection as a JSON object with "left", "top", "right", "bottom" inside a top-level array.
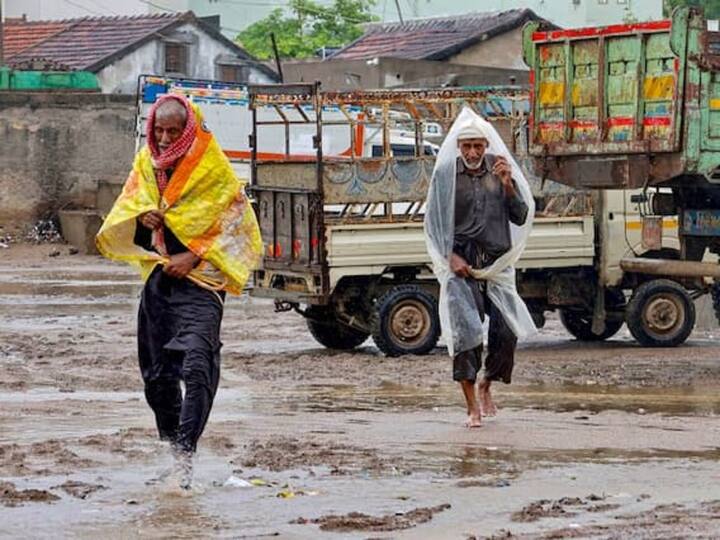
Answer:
[{"left": 96, "top": 95, "right": 262, "bottom": 489}]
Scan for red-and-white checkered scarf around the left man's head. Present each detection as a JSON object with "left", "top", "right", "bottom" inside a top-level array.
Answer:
[{"left": 146, "top": 94, "right": 197, "bottom": 193}]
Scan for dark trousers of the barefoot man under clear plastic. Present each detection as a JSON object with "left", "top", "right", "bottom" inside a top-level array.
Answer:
[{"left": 453, "top": 278, "right": 517, "bottom": 384}]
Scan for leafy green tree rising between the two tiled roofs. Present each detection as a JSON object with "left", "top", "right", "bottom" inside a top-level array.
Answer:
[{"left": 237, "top": 0, "right": 377, "bottom": 59}]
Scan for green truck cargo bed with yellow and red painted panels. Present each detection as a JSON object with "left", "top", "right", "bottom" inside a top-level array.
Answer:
[{"left": 523, "top": 8, "right": 720, "bottom": 188}]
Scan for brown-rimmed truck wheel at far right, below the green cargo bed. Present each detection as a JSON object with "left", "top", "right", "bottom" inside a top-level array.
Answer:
[{"left": 625, "top": 279, "right": 695, "bottom": 347}]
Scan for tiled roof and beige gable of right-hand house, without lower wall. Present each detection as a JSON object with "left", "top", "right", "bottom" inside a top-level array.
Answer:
[{"left": 330, "top": 9, "right": 541, "bottom": 70}]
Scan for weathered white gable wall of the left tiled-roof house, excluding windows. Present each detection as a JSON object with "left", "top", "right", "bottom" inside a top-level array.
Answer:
[{"left": 97, "top": 24, "right": 273, "bottom": 94}]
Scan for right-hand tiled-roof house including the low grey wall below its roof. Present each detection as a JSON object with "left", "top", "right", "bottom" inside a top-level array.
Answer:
[{"left": 283, "top": 9, "right": 555, "bottom": 90}]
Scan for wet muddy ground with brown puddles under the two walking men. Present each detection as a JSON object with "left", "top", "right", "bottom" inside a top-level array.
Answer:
[{"left": 0, "top": 250, "right": 720, "bottom": 538}]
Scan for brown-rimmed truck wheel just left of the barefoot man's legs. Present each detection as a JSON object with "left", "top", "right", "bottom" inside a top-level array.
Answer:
[{"left": 372, "top": 285, "right": 440, "bottom": 356}]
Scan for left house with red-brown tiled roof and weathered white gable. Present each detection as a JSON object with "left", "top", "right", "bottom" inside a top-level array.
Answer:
[{"left": 3, "top": 12, "right": 277, "bottom": 94}]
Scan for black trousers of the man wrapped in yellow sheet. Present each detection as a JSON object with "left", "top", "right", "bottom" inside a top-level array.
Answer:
[{"left": 138, "top": 266, "right": 224, "bottom": 452}]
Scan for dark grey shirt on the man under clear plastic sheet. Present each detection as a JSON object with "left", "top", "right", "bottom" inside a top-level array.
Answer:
[{"left": 453, "top": 154, "right": 528, "bottom": 267}]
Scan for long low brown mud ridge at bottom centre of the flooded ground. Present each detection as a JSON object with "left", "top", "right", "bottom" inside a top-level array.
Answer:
[{"left": 293, "top": 504, "right": 450, "bottom": 532}]
